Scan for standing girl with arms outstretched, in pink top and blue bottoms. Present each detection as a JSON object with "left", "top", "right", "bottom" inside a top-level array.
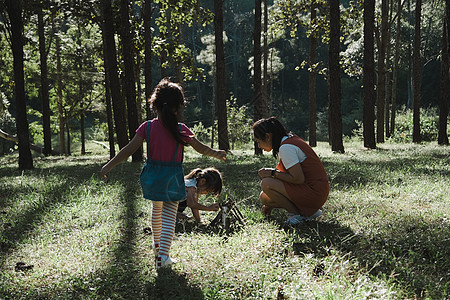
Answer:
[{"left": 101, "top": 79, "right": 226, "bottom": 269}]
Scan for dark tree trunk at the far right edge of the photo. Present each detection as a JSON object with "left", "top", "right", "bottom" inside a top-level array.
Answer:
[{"left": 438, "top": 1, "right": 450, "bottom": 145}]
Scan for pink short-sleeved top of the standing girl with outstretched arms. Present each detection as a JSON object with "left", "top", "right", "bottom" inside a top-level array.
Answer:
[{"left": 136, "top": 118, "right": 194, "bottom": 162}]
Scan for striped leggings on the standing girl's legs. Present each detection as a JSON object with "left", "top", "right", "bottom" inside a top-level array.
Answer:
[{"left": 152, "top": 201, "right": 178, "bottom": 256}]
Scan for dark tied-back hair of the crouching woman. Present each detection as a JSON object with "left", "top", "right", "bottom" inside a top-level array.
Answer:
[{"left": 252, "top": 117, "right": 288, "bottom": 157}]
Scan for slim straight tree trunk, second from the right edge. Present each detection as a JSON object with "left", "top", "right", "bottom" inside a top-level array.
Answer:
[{"left": 413, "top": 0, "right": 422, "bottom": 143}]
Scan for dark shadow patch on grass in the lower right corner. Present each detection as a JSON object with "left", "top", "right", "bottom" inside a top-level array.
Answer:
[{"left": 284, "top": 219, "right": 450, "bottom": 299}]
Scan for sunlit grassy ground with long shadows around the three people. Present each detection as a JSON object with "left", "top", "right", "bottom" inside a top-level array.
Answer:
[{"left": 0, "top": 143, "right": 450, "bottom": 299}]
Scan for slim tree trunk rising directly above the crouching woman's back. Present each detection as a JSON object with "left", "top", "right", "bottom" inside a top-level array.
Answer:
[{"left": 308, "top": 4, "right": 317, "bottom": 147}]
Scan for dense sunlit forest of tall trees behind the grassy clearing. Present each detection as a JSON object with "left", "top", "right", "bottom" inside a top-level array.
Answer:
[{"left": 0, "top": 0, "right": 448, "bottom": 167}]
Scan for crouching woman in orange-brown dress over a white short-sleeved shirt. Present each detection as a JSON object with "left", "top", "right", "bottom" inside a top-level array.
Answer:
[{"left": 253, "top": 117, "right": 330, "bottom": 225}]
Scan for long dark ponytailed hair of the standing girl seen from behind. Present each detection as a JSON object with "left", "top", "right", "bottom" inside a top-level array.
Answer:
[{"left": 148, "top": 78, "right": 186, "bottom": 145}]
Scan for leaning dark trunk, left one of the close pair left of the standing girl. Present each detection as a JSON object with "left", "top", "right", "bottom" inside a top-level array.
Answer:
[{"left": 101, "top": 0, "right": 128, "bottom": 149}]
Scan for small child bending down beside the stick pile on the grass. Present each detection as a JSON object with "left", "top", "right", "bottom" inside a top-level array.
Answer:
[{"left": 177, "top": 168, "right": 222, "bottom": 223}]
